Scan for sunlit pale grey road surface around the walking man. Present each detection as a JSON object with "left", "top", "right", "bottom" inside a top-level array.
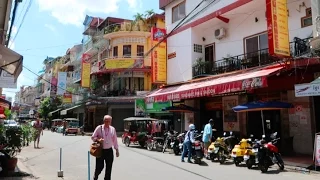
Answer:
[{"left": 20, "top": 131, "right": 319, "bottom": 180}]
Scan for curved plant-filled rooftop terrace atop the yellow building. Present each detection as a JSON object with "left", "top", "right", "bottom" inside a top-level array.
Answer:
[{"left": 103, "top": 22, "right": 151, "bottom": 39}]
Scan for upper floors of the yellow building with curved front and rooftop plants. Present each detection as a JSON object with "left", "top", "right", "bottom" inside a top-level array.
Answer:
[{"left": 100, "top": 14, "right": 165, "bottom": 92}]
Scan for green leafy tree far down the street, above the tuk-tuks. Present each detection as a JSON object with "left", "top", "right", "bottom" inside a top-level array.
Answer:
[{"left": 38, "top": 97, "right": 62, "bottom": 119}]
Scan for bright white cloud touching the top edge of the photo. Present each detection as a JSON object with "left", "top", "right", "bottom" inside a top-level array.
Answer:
[{"left": 38, "top": 0, "right": 121, "bottom": 26}]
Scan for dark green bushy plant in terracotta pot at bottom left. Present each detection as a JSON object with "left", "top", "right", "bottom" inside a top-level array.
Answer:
[{"left": 4, "top": 128, "right": 22, "bottom": 171}]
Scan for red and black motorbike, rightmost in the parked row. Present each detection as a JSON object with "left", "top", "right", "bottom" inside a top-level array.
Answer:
[{"left": 258, "top": 132, "right": 284, "bottom": 173}]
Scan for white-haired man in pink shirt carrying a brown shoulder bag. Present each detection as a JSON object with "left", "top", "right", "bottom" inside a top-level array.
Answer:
[{"left": 91, "top": 115, "right": 119, "bottom": 180}]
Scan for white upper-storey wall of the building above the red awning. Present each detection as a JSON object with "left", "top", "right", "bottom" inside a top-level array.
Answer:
[{"left": 165, "top": 0, "right": 312, "bottom": 84}]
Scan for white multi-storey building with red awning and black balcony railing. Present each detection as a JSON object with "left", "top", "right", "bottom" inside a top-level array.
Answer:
[{"left": 146, "top": 0, "right": 320, "bottom": 154}]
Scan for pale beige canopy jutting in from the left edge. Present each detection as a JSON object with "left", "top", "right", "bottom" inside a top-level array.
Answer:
[{"left": 0, "top": 45, "right": 23, "bottom": 82}]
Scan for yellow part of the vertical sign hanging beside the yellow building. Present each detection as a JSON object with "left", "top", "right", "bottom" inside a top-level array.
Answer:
[{"left": 152, "top": 41, "right": 167, "bottom": 83}]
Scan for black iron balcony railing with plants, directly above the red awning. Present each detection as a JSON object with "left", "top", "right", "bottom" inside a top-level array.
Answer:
[{"left": 192, "top": 38, "right": 311, "bottom": 78}]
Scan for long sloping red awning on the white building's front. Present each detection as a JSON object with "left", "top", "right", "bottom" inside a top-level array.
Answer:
[{"left": 146, "top": 66, "right": 283, "bottom": 103}]
